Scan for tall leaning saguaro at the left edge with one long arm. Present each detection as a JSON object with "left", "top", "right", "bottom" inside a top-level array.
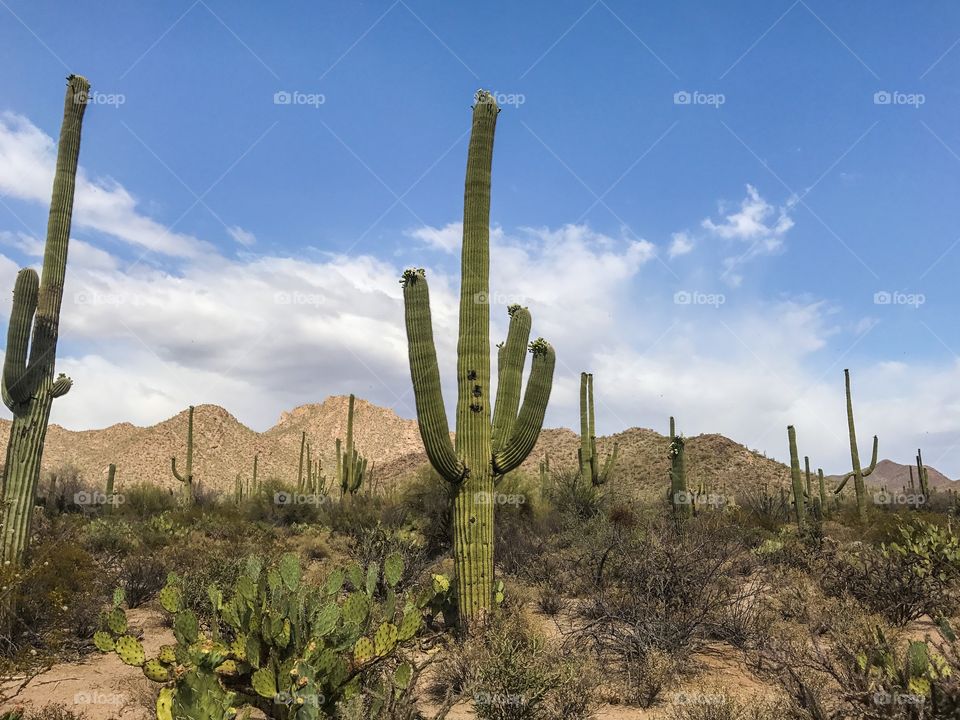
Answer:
[{"left": 0, "top": 75, "right": 90, "bottom": 565}]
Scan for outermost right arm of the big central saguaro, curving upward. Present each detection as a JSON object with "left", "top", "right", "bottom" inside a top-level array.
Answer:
[{"left": 493, "top": 338, "right": 557, "bottom": 475}]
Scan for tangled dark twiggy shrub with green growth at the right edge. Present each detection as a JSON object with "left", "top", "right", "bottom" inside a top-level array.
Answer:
[{"left": 818, "top": 520, "right": 960, "bottom": 627}]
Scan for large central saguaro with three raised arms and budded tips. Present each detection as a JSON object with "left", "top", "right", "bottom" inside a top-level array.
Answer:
[{"left": 401, "top": 91, "right": 556, "bottom": 631}]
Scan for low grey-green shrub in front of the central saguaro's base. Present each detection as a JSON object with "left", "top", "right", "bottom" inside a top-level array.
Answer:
[{"left": 430, "top": 611, "right": 597, "bottom": 720}]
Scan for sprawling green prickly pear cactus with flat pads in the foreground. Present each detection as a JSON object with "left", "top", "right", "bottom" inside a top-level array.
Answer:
[{"left": 94, "top": 553, "right": 444, "bottom": 720}]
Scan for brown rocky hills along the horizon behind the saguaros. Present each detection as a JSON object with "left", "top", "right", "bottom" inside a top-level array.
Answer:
[{"left": 0, "top": 396, "right": 950, "bottom": 495}]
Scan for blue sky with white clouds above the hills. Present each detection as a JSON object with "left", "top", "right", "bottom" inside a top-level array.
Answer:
[{"left": 0, "top": 0, "right": 960, "bottom": 476}]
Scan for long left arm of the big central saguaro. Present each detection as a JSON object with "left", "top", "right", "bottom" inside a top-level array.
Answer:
[{"left": 402, "top": 270, "right": 465, "bottom": 482}]
